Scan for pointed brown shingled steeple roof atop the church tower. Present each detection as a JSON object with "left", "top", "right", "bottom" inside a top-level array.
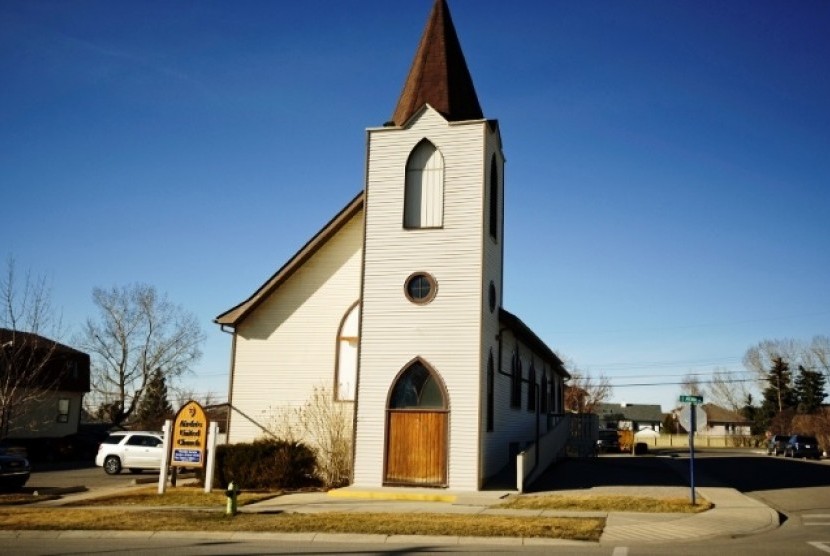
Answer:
[{"left": 392, "top": 0, "right": 484, "bottom": 126}]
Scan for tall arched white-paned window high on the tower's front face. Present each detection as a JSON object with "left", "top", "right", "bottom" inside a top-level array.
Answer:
[{"left": 403, "top": 139, "right": 444, "bottom": 228}]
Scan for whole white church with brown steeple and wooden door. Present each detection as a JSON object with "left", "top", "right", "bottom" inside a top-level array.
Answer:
[{"left": 215, "top": 0, "right": 569, "bottom": 490}]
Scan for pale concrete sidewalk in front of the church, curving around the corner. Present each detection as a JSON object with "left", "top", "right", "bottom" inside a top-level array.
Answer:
[{"left": 9, "top": 474, "right": 778, "bottom": 546}]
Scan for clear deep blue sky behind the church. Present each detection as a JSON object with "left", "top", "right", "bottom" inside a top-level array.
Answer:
[{"left": 0, "top": 0, "right": 830, "bottom": 410}]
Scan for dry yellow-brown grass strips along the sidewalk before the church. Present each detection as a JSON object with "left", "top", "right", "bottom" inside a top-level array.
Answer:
[{"left": 0, "top": 487, "right": 712, "bottom": 541}]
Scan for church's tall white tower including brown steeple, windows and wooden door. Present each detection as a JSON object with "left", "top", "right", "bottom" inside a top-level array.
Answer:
[{"left": 353, "top": 0, "right": 504, "bottom": 490}]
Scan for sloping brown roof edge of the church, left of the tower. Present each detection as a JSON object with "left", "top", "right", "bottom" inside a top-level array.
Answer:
[{"left": 213, "top": 191, "right": 364, "bottom": 326}]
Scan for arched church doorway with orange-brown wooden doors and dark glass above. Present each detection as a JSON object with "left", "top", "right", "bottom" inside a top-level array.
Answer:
[{"left": 384, "top": 359, "right": 449, "bottom": 486}]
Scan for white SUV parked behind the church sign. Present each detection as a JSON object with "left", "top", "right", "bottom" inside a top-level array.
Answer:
[{"left": 95, "top": 431, "right": 164, "bottom": 475}]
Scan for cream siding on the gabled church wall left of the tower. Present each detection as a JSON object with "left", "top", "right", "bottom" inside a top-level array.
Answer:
[{"left": 228, "top": 212, "right": 363, "bottom": 442}]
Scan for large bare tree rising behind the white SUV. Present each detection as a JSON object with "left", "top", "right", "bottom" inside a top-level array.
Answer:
[{"left": 79, "top": 284, "right": 204, "bottom": 424}]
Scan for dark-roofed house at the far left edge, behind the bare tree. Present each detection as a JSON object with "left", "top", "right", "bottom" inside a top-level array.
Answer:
[{"left": 0, "top": 328, "right": 90, "bottom": 440}]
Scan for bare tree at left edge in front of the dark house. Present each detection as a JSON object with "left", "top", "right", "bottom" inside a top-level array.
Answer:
[{"left": 0, "top": 258, "right": 65, "bottom": 439}]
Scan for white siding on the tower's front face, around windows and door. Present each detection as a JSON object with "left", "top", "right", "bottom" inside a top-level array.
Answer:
[{"left": 354, "top": 108, "right": 486, "bottom": 490}]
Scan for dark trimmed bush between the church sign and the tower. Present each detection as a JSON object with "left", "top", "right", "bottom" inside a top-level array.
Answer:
[{"left": 216, "top": 439, "right": 320, "bottom": 490}]
